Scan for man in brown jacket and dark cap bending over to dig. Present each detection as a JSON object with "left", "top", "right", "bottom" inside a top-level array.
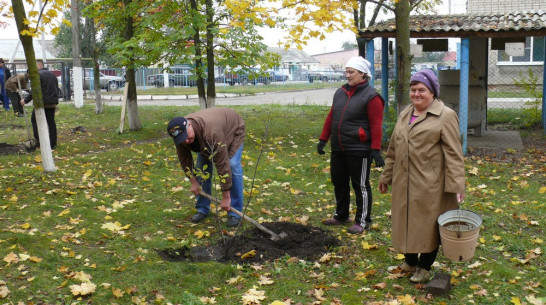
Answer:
[{"left": 167, "top": 108, "right": 245, "bottom": 227}]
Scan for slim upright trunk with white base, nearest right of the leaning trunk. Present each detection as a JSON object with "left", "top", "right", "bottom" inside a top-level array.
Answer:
[{"left": 70, "top": 0, "right": 83, "bottom": 108}]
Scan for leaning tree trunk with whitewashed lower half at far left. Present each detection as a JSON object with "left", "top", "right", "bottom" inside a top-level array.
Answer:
[{"left": 11, "top": 0, "right": 57, "bottom": 172}]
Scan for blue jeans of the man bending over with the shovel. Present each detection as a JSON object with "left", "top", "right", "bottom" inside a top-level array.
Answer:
[{"left": 195, "top": 145, "right": 244, "bottom": 218}]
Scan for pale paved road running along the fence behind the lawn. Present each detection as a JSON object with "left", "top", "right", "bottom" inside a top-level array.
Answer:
[{"left": 100, "top": 88, "right": 337, "bottom": 106}]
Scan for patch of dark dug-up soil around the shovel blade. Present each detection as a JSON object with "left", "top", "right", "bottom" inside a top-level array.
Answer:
[{"left": 157, "top": 222, "right": 339, "bottom": 263}]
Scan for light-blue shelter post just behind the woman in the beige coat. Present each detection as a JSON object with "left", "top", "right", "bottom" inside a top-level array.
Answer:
[{"left": 459, "top": 38, "right": 470, "bottom": 155}]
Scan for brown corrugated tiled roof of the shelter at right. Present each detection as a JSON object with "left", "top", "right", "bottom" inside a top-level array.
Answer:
[{"left": 359, "top": 10, "right": 546, "bottom": 38}]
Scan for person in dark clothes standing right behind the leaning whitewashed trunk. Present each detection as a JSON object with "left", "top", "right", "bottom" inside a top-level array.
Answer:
[{"left": 21, "top": 59, "right": 59, "bottom": 149}]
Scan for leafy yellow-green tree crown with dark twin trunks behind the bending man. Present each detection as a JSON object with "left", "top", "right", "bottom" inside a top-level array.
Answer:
[{"left": 85, "top": 0, "right": 279, "bottom": 108}]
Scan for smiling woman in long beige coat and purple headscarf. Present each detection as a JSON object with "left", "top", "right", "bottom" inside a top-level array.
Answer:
[{"left": 379, "top": 70, "right": 465, "bottom": 283}]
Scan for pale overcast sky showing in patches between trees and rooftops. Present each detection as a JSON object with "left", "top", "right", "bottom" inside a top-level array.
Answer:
[{"left": 2, "top": 0, "right": 466, "bottom": 55}]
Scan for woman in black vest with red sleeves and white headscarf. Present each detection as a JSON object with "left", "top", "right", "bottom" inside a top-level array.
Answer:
[{"left": 317, "top": 56, "right": 385, "bottom": 234}]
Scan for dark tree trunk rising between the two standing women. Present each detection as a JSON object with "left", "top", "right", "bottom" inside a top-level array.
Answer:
[{"left": 395, "top": 1, "right": 411, "bottom": 114}]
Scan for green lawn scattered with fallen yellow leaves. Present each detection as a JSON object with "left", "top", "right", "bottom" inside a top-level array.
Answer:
[{"left": 0, "top": 103, "right": 546, "bottom": 304}]
